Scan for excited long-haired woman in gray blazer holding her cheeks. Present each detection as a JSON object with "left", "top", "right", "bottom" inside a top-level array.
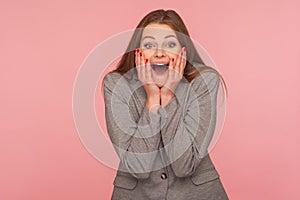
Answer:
[{"left": 104, "top": 10, "right": 228, "bottom": 200}]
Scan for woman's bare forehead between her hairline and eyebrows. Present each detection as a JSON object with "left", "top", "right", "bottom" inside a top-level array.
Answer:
[{"left": 142, "top": 24, "right": 176, "bottom": 39}]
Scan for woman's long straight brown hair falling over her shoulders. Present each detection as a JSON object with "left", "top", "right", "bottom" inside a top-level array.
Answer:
[{"left": 103, "top": 9, "right": 227, "bottom": 94}]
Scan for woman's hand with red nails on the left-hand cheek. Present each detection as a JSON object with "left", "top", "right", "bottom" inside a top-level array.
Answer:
[{"left": 135, "top": 49, "right": 160, "bottom": 113}]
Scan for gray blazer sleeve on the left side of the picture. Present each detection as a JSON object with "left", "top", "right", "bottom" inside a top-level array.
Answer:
[{"left": 104, "top": 74, "right": 160, "bottom": 179}]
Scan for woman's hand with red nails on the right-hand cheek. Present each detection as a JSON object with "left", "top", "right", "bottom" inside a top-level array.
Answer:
[{"left": 161, "top": 47, "right": 186, "bottom": 107}]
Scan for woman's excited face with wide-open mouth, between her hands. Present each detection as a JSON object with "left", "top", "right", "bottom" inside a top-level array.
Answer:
[{"left": 140, "top": 23, "right": 182, "bottom": 87}]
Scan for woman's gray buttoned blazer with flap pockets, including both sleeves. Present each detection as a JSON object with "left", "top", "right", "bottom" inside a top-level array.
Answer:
[{"left": 104, "top": 64, "right": 228, "bottom": 200}]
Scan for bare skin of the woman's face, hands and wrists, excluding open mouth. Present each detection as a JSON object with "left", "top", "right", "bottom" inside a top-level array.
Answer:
[{"left": 135, "top": 23, "right": 186, "bottom": 114}]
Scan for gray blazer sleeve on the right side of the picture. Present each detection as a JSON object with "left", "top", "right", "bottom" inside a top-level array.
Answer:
[{"left": 159, "top": 72, "right": 220, "bottom": 177}]
